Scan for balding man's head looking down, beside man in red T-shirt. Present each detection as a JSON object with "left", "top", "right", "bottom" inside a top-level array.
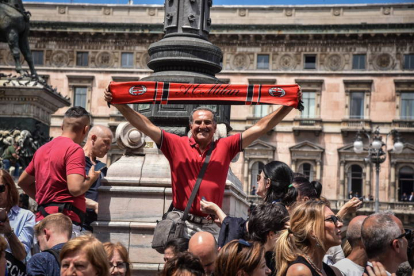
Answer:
[{"left": 86, "top": 125, "right": 112, "bottom": 158}]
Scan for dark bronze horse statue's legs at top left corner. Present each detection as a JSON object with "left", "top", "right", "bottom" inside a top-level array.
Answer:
[{"left": 0, "top": 0, "right": 37, "bottom": 78}]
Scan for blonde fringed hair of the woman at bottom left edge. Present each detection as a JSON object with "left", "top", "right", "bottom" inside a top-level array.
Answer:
[{"left": 59, "top": 235, "right": 109, "bottom": 276}]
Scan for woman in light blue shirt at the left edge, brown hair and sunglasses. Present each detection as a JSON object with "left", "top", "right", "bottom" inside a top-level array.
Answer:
[{"left": 0, "top": 170, "right": 35, "bottom": 261}]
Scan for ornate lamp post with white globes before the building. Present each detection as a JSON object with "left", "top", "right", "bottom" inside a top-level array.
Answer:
[{"left": 354, "top": 127, "right": 404, "bottom": 213}]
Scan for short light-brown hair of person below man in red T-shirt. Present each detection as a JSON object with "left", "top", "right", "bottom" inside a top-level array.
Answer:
[{"left": 34, "top": 213, "right": 72, "bottom": 240}]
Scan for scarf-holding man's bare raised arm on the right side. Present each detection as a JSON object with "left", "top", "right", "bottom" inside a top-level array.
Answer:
[{"left": 242, "top": 106, "right": 293, "bottom": 149}]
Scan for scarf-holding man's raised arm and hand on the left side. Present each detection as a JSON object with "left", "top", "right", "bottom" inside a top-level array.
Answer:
[{"left": 105, "top": 90, "right": 161, "bottom": 145}]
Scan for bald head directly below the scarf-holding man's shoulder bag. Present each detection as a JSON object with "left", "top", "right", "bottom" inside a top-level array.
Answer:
[{"left": 188, "top": 232, "right": 217, "bottom": 275}]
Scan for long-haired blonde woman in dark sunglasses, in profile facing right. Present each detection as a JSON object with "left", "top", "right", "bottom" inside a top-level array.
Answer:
[{"left": 275, "top": 200, "right": 343, "bottom": 276}]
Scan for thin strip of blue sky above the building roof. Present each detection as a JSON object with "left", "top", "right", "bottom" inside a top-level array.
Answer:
[{"left": 28, "top": 0, "right": 414, "bottom": 5}]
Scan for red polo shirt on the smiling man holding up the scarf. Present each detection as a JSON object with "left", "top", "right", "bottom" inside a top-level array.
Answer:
[{"left": 160, "top": 130, "right": 242, "bottom": 217}]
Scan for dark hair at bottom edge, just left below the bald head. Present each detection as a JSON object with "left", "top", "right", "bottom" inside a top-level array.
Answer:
[{"left": 160, "top": 251, "right": 205, "bottom": 276}]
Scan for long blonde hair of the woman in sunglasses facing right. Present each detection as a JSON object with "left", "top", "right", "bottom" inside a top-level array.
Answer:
[{"left": 275, "top": 200, "right": 327, "bottom": 276}]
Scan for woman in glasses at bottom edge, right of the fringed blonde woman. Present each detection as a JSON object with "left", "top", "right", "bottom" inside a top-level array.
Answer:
[{"left": 103, "top": 242, "right": 131, "bottom": 276}]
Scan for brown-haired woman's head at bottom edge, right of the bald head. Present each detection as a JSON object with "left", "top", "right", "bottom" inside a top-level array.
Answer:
[{"left": 214, "top": 239, "right": 271, "bottom": 276}]
